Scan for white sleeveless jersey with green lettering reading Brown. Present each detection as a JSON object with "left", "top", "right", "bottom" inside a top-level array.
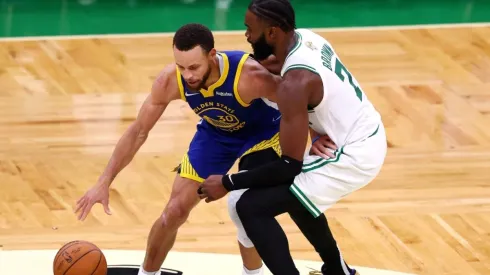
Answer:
[{"left": 281, "top": 29, "right": 381, "bottom": 147}]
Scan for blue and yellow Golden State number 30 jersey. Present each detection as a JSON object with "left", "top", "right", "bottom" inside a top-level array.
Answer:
[{"left": 177, "top": 51, "right": 281, "bottom": 138}]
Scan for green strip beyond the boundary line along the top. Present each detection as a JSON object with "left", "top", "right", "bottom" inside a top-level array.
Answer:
[{"left": 0, "top": 0, "right": 490, "bottom": 37}]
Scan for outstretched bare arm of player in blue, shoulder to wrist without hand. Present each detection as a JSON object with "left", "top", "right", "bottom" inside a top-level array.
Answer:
[{"left": 99, "top": 65, "right": 180, "bottom": 188}]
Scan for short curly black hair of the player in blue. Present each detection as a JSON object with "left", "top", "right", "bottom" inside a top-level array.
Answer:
[{"left": 173, "top": 23, "right": 214, "bottom": 53}]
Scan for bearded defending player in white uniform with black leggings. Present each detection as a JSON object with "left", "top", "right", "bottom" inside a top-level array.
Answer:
[{"left": 199, "top": 0, "right": 387, "bottom": 275}]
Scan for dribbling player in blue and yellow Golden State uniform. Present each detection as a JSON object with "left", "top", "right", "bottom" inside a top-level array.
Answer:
[{"left": 76, "top": 24, "right": 336, "bottom": 275}]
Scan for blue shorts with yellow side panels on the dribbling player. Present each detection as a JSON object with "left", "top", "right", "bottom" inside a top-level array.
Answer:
[{"left": 179, "top": 121, "right": 281, "bottom": 182}]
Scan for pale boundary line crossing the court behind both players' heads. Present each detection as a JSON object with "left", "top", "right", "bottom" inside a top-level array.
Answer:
[{"left": 0, "top": 22, "right": 490, "bottom": 42}]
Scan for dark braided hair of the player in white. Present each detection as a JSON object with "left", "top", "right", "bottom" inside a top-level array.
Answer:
[{"left": 248, "top": 0, "right": 296, "bottom": 32}]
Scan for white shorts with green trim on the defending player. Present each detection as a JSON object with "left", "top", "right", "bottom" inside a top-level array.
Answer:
[{"left": 290, "top": 124, "right": 387, "bottom": 217}]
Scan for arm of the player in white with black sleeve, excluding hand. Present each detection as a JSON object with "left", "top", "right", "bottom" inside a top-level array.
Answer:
[{"left": 223, "top": 70, "right": 322, "bottom": 191}]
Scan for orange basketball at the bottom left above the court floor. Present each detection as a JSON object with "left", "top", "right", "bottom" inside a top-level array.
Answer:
[{"left": 53, "top": 241, "right": 107, "bottom": 275}]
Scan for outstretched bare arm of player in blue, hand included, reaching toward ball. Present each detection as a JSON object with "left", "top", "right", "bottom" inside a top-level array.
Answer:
[{"left": 75, "top": 65, "right": 180, "bottom": 220}]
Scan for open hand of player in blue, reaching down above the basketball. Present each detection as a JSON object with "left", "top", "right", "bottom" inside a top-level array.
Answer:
[{"left": 75, "top": 183, "right": 112, "bottom": 221}]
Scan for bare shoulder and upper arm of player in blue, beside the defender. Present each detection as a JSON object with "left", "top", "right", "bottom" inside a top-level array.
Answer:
[{"left": 238, "top": 58, "right": 282, "bottom": 104}]
